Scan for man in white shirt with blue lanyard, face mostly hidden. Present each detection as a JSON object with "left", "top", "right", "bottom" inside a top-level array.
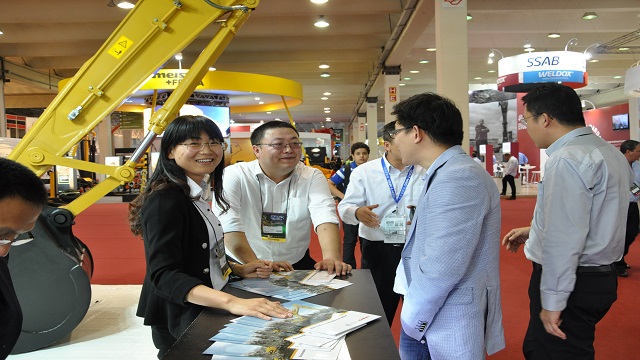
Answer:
[{"left": 338, "top": 122, "right": 426, "bottom": 325}]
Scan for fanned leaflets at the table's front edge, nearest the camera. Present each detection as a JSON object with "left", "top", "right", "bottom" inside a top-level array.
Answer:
[{"left": 204, "top": 300, "right": 380, "bottom": 360}]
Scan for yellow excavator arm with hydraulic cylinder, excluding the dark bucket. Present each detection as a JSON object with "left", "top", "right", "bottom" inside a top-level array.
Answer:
[{"left": 9, "top": 0, "right": 259, "bottom": 215}]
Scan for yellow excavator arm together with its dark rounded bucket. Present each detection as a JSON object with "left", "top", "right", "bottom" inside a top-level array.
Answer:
[{"left": 4, "top": 0, "right": 259, "bottom": 354}]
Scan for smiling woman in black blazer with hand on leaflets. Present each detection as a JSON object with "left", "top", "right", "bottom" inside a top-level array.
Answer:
[{"left": 129, "top": 115, "right": 291, "bottom": 358}]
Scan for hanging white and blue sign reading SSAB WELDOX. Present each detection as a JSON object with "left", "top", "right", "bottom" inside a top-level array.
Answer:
[{"left": 498, "top": 51, "right": 587, "bottom": 85}]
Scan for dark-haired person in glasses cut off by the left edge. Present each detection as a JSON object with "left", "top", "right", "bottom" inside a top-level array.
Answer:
[{"left": 0, "top": 157, "right": 48, "bottom": 359}]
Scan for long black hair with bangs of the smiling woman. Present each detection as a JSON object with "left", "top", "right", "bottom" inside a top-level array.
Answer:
[{"left": 129, "top": 115, "right": 229, "bottom": 235}]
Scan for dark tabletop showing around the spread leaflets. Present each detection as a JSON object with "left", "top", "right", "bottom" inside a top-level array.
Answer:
[{"left": 162, "top": 270, "right": 400, "bottom": 360}]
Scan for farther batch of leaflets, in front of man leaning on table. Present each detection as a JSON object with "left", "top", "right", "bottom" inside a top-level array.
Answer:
[{"left": 229, "top": 270, "right": 351, "bottom": 301}]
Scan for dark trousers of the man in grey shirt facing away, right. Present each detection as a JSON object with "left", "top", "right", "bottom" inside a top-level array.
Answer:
[{"left": 522, "top": 262, "right": 618, "bottom": 360}]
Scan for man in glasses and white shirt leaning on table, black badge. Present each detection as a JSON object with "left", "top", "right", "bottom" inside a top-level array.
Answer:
[{"left": 214, "top": 121, "right": 351, "bottom": 275}]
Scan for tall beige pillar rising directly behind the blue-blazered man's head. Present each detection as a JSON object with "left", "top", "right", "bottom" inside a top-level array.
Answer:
[{"left": 434, "top": 0, "right": 469, "bottom": 149}]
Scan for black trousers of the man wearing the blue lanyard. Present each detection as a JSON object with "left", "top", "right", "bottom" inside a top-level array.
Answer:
[{"left": 360, "top": 237, "right": 403, "bottom": 326}]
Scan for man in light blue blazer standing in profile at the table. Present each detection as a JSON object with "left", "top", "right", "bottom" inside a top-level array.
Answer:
[{"left": 390, "top": 93, "right": 505, "bottom": 360}]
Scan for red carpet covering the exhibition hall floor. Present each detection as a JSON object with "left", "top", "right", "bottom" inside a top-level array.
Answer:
[{"left": 74, "top": 198, "right": 640, "bottom": 360}]
